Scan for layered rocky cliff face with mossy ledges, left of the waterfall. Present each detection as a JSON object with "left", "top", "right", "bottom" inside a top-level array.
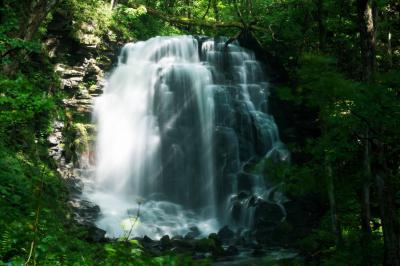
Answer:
[{"left": 45, "top": 17, "right": 118, "bottom": 241}]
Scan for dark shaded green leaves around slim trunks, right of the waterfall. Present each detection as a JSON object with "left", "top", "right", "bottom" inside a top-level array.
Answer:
[{"left": 274, "top": 43, "right": 400, "bottom": 265}]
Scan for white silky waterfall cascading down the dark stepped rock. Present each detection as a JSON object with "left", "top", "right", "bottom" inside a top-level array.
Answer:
[{"left": 85, "top": 36, "right": 288, "bottom": 238}]
